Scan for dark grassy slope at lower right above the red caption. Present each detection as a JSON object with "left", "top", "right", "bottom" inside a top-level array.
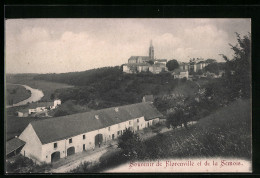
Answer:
[{"left": 146, "top": 100, "right": 252, "bottom": 159}]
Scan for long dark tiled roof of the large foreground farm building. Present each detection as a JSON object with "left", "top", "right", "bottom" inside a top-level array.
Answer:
[{"left": 31, "top": 103, "right": 162, "bottom": 144}]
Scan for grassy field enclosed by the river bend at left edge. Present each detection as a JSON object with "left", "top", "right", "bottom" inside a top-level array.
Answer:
[{"left": 6, "top": 84, "right": 31, "bottom": 105}]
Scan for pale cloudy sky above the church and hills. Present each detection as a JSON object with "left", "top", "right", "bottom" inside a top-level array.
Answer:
[{"left": 5, "top": 18, "right": 251, "bottom": 73}]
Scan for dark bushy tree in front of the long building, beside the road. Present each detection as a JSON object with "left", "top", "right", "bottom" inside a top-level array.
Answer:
[{"left": 118, "top": 129, "right": 146, "bottom": 160}]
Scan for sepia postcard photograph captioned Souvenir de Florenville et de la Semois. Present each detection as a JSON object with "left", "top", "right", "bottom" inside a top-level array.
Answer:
[{"left": 4, "top": 18, "right": 252, "bottom": 174}]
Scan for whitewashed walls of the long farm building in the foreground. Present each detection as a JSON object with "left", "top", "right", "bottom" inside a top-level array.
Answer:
[{"left": 24, "top": 117, "right": 159, "bottom": 163}]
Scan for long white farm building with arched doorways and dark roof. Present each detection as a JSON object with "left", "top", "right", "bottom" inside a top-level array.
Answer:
[{"left": 16, "top": 103, "right": 162, "bottom": 163}]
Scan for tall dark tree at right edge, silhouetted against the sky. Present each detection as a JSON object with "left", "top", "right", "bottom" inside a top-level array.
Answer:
[{"left": 220, "top": 33, "right": 251, "bottom": 98}]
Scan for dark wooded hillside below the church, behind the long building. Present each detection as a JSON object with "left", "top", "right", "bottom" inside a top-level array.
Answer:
[{"left": 31, "top": 66, "right": 198, "bottom": 109}]
